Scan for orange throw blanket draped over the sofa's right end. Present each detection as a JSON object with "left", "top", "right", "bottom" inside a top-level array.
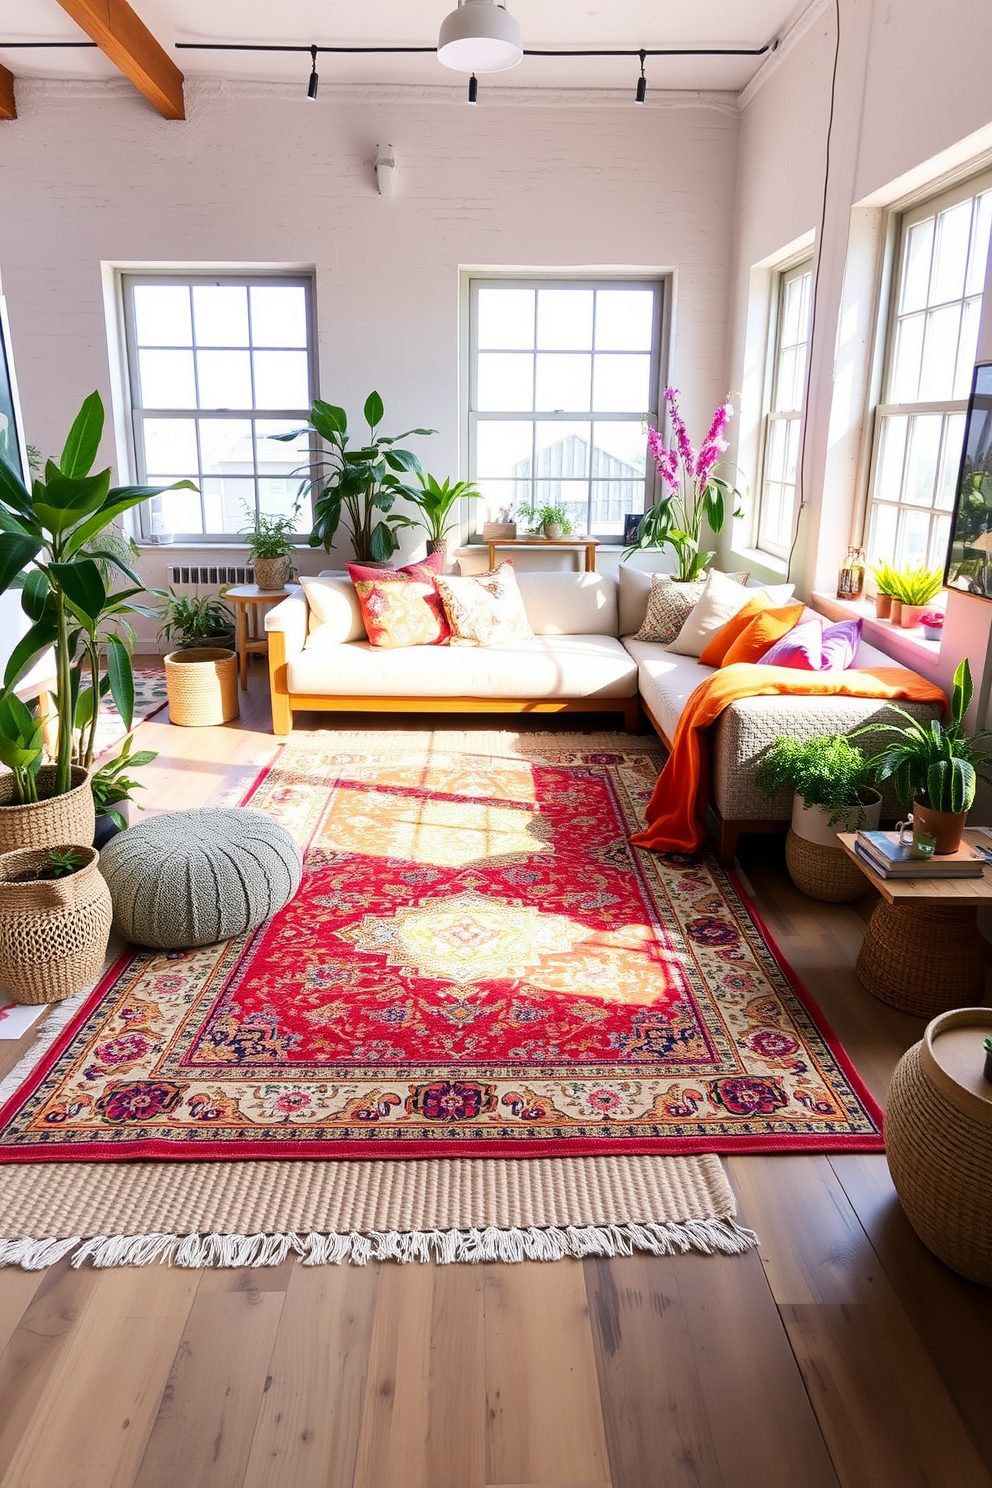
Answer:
[{"left": 631, "top": 662, "right": 947, "bottom": 853}]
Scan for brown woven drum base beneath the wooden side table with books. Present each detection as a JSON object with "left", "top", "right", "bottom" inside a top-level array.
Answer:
[{"left": 855, "top": 899, "right": 985, "bottom": 1018}]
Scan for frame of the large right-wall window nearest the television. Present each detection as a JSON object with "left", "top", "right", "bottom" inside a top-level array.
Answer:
[{"left": 863, "top": 170, "right": 992, "bottom": 570}]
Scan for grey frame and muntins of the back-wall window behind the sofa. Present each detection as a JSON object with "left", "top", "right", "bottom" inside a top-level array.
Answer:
[{"left": 464, "top": 272, "right": 672, "bottom": 546}]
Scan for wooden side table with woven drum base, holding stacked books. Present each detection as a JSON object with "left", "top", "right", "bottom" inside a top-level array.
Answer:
[{"left": 837, "top": 832, "right": 992, "bottom": 1018}]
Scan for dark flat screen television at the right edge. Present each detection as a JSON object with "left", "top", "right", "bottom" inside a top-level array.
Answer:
[{"left": 944, "top": 362, "right": 992, "bottom": 600}]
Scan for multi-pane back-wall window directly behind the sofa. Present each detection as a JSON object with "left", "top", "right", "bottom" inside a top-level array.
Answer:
[{"left": 468, "top": 280, "right": 662, "bottom": 540}]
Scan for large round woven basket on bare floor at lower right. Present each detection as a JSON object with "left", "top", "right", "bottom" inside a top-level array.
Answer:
[{"left": 885, "top": 1007, "right": 992, "bottom": 1287}]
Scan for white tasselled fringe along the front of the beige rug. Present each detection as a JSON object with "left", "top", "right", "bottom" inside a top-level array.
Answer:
[{"left": 0, "top": 1219, "right": 757, "bottom": 1271}]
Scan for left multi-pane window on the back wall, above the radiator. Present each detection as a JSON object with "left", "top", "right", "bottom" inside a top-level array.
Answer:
[{"left": 123, "top": 274, "right": 314, "bottom": 540}]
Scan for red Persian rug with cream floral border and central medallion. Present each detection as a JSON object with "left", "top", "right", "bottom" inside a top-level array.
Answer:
[{"left": 0, "top": 732, "right": 882, "bottom": 1162}]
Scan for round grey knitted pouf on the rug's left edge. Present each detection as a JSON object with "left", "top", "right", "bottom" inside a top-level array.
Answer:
[{"left": 100, "top": 806, "right": 300, "bottom": 951}]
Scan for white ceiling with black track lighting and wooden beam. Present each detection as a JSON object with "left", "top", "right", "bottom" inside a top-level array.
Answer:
[{"left": 0, "top": 0, "right": 809, "bottom": 100}]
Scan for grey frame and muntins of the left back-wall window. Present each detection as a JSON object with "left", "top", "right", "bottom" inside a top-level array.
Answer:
[{"left": 119, "top": 269, "right": 318, "bottom": 548}]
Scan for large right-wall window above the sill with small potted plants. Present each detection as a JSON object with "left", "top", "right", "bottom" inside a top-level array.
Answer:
[{"left": 867, "top": 176, "right": 992, "bottom": 568}]
